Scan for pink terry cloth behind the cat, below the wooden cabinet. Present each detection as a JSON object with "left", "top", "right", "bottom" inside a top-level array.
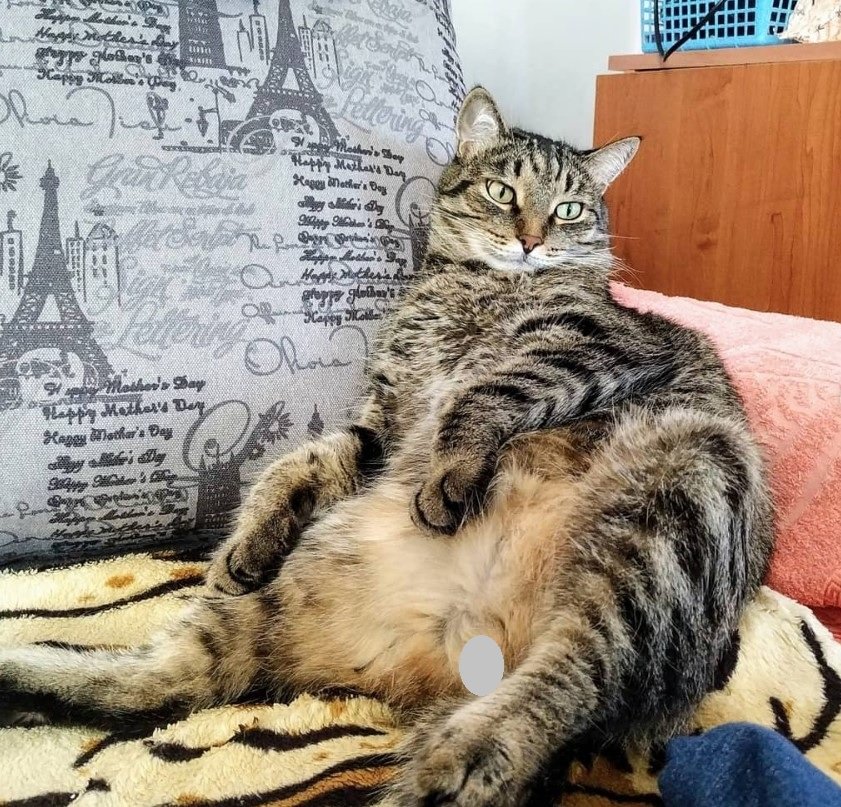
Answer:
[{"left": 614, "top": 285, "right": 841, "bottom": 625}]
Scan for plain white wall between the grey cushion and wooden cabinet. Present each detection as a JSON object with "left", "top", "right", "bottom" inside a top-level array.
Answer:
[{"left": 450, "top": 0, "right": 640, "bottom": 146}]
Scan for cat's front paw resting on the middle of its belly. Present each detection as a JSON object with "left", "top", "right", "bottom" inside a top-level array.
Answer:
[{"left": 412, "top": 456, "right": 492, "bottom": 535}]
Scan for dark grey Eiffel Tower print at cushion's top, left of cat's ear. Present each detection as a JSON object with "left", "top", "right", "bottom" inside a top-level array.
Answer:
[{"left": 223, "top": 0, "right": 339, "bottom": 154}]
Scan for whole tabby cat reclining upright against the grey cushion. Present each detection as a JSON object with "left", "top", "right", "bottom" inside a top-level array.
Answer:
[{"left": 0, "top": 88, "right": 772, "bottom": 807}]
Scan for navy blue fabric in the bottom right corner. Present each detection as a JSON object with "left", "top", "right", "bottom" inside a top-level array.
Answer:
[{"left": 659, "top": 723, "right": 841, "bottom": 807}]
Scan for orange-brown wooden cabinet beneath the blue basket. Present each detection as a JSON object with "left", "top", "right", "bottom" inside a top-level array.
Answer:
[{"left": 595, "top": 43, "right": 841, "bottom": 320}]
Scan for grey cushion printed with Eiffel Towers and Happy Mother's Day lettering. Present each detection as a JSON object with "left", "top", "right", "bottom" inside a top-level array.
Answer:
[{"left": 0, "top": 0, "right": 463, "bottom": 563}]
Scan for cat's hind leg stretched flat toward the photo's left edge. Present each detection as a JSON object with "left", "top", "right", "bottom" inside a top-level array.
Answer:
[{"left": 0, "top": 593, "right": 266, "bottom": 723}]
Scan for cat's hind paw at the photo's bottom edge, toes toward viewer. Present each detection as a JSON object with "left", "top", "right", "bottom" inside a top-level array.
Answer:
[{"left": 398, "top": 714, "right": 526, "bottom": 807}]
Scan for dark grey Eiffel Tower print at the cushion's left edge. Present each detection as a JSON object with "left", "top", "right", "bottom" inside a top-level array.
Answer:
[{"left": 0, "top": 162, "right": 113, "bottom": 410}]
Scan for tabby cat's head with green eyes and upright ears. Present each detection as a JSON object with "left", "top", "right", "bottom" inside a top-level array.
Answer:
[{"left": 431, "top": 87, "right": 640, "bottom": 272}]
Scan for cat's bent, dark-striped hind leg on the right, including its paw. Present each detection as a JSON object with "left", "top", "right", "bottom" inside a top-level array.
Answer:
[{"left": 395, "top": 408, "right": 772, "bottom": 807}]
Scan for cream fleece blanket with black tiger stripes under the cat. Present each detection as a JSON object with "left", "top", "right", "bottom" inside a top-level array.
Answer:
[{"left": 0, "top": 555, "right": 841, "bottom": 807}]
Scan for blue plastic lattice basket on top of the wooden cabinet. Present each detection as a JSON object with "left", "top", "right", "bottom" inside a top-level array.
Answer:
[{"left": 640, "top": 0, "right": 797, "bottom": 53}]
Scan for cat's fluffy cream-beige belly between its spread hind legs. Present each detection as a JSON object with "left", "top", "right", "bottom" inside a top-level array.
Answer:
[{"left": 278, "top": 436, "right": 575, "bottom": 704}]
